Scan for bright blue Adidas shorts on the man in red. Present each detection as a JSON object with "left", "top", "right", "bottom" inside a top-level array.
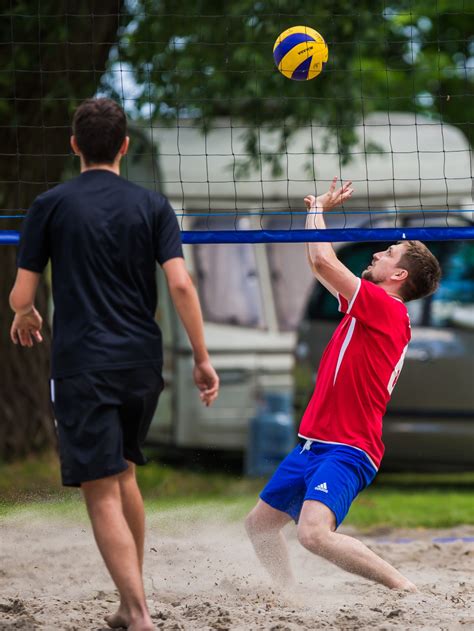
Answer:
[{"left": 260, "top": 441, "right": 377, "bottom": 528}]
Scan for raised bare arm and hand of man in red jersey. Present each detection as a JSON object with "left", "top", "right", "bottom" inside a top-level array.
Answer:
[{"left": 304, "top": 177, "right": 359, "bottom": 302}]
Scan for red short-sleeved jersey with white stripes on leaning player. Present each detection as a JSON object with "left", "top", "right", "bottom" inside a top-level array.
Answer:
[{"left": 299, "top": 280, "right": 411, "bottom": 469}]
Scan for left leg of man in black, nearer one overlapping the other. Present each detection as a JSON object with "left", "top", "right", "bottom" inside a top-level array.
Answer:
[{"left": 82, "top": 475, "right": 155, "bottom": 631}]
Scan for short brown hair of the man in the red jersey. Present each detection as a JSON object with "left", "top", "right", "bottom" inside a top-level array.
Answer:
[{"left": 397, "top": 241, "right": 441, "bottom": 302}]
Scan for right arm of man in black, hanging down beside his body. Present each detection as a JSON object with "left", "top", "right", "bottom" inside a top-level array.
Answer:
[{"left": 163, "top": 258, "right": 219, "bottom": 405}]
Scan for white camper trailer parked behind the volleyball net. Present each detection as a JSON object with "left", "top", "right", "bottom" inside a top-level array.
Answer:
[{"left": 124, "top": 113, "right": 472, "bottom": 450}]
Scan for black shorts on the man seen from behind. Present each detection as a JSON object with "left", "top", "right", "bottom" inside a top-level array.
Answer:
[{"left": 51, "top": 365, "right": 163, "bottom": 486}]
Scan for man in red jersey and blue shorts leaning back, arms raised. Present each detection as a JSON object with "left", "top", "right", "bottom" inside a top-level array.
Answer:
[{"left": 246, "top": 178, "right": 441, "bottom": 591}]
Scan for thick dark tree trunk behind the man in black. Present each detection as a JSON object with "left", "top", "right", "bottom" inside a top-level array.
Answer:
[{"left": 0, "top": 0, "right": 123, "bottom": 460}]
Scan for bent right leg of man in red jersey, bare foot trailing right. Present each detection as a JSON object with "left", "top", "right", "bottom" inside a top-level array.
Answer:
[{"left": 298, "top": 500, "right": 417, "bottom": 591}]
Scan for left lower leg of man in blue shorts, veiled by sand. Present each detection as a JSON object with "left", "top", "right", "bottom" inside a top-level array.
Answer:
[{"left": 245, "top": 500, "right": 294, "bottom": 585}]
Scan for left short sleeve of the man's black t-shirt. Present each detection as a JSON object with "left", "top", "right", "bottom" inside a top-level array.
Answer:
[{"left": 17, "top": 198, "right": 50, "bottom": 274}]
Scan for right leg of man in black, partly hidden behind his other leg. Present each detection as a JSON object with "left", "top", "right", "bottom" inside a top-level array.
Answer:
[{"left": 105, "top": 461, "right": 145, "bottom": 628}]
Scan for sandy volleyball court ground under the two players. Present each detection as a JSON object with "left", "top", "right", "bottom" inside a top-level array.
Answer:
[{"left": 0, "top": 510, "right": 474, "bottom": 631}]
